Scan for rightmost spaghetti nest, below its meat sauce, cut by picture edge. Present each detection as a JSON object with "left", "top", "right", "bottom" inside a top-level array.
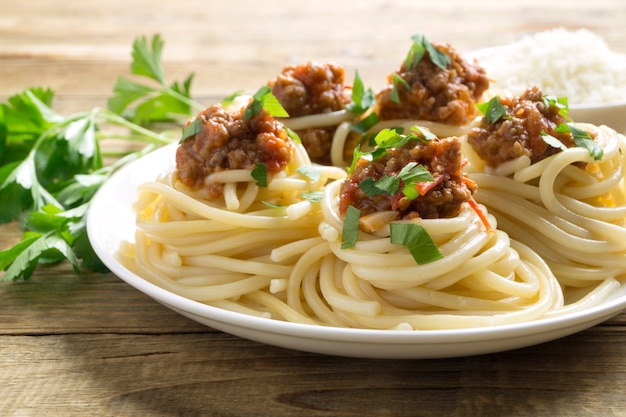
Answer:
[{"left": 465, "top": 89, "right": 626, "bottom": 290}]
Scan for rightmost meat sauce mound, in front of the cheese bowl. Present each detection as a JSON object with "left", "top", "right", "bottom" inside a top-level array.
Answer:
[{"left": 467, "top": 87, "right": 575, "bottom": 168}]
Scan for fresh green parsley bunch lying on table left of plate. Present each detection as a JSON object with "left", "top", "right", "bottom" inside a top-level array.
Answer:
[{"left": 0, "top": 35, "right": 192, "bottom": 281}]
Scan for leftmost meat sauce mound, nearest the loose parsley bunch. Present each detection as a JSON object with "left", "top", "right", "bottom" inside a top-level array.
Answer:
[{"left": 176, "top": 104, "right": 295, "bottom": 198}]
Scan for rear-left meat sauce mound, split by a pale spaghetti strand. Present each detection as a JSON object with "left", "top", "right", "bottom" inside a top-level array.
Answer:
[{"left": 268, "top": 62, "right": 350, "bottom": 163}]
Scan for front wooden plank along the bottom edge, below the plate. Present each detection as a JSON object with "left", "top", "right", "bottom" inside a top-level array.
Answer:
[{"left": 0, "top": 330, "right": 626, "bottom": 416}]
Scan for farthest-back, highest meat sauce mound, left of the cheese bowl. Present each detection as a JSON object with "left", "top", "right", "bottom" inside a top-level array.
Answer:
[{"left": 376, "top": 44, "right": 489, "bottom": 126}]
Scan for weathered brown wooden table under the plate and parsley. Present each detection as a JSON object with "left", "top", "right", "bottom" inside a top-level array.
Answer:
[{"left": 0, "top": 0, "right": 626, "bottom": 416}]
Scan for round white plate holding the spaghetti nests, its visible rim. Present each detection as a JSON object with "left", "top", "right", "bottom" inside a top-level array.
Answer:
[{"left": 87, "top": 145, "right": 626, "bottom": 358}]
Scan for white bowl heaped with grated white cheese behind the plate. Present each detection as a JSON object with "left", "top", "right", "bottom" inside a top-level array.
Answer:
[{"left": 469, "top": 28, "right": 626, "bottom": 132}]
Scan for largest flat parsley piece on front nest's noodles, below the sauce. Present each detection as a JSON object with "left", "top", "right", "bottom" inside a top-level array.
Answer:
[{"left": 389, "top": 223, "right": 443, "bottom": 265}]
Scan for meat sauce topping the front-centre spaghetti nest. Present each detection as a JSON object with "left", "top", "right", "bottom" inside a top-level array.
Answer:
[{"left": 339, "top": 137, "right": 476, "bottom": 219}]
